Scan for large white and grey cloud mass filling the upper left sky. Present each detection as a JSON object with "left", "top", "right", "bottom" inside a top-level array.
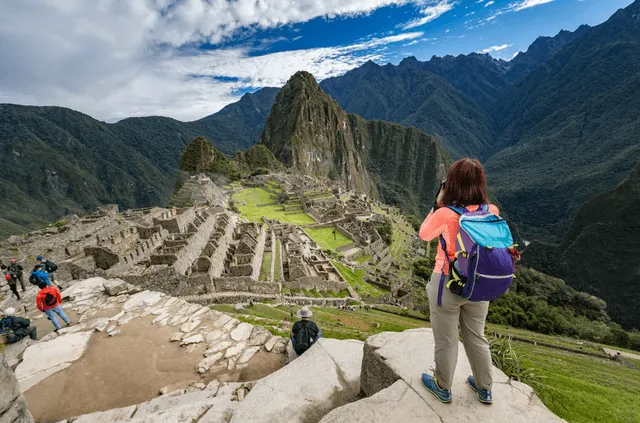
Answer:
[{"left": 0, "top": 0, "right": 429, "bottom": 120}]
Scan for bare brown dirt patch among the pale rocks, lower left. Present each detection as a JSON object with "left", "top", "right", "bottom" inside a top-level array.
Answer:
[{"left": 25, "top": 317, "right": 284, "bottom": 423}]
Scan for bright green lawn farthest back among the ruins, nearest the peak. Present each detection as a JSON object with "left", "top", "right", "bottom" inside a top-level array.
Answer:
[{"left": 231, "top": 188, "right": 315, "bottom": 225}]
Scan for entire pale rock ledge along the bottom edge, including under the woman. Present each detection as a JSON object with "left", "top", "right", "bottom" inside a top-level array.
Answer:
[{"left": 43, "top": 326, "right": 562, "bottom": 423}]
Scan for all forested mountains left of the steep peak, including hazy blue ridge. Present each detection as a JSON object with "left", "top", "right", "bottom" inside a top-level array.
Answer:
[{"left": 0, "top": 88, "right": 278, "bottom": 236}]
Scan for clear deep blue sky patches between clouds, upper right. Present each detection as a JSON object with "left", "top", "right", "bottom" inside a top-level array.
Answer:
[{"left": 218, "top": 0, "right": 632, "bottom": 64}]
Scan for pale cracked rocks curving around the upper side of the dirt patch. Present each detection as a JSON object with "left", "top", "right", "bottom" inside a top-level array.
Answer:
[{"left": 16, "top": 277, "right": 286, "bottom": 398}]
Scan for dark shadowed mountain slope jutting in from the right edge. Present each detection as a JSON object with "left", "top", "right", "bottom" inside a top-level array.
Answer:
[{"left": 523, "top": 163, "right": 640, "bottom": 328}]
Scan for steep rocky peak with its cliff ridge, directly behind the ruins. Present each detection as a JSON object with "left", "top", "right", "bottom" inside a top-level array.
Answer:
[{"left": 261, "top": 72, "right": 450, "bottom": 214}]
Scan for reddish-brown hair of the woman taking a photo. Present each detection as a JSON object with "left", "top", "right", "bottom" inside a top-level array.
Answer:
[{"left": 442, "top": 158, "right": 489, "bottom": 206}]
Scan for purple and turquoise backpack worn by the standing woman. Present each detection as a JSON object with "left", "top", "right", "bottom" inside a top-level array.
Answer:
[{"left": 438, "top": 204, "right": 519, "bottom": 305}]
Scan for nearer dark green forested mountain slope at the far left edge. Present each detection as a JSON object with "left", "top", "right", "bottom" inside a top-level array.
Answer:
[{"left": 0, "top": 105, "right": 171, "bottom": 236}]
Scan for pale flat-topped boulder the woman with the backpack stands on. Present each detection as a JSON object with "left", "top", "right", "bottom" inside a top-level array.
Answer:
[{"left": 321, "top": 328, "right": 563, "bottom": 423}]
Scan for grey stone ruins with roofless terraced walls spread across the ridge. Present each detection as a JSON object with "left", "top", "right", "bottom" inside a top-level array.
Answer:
[{"left": 0, "top": 174, "right": 410, "bottom": 310}]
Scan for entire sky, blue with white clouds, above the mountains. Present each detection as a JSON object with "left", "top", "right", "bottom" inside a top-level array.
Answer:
[{"left": 0, "top": 0, "right": 632, "bottom": 121}]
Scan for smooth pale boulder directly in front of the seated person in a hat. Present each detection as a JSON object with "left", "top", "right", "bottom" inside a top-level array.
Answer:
[{"left": 231, "top": 339, "right": 363, "bottom": 423}]
